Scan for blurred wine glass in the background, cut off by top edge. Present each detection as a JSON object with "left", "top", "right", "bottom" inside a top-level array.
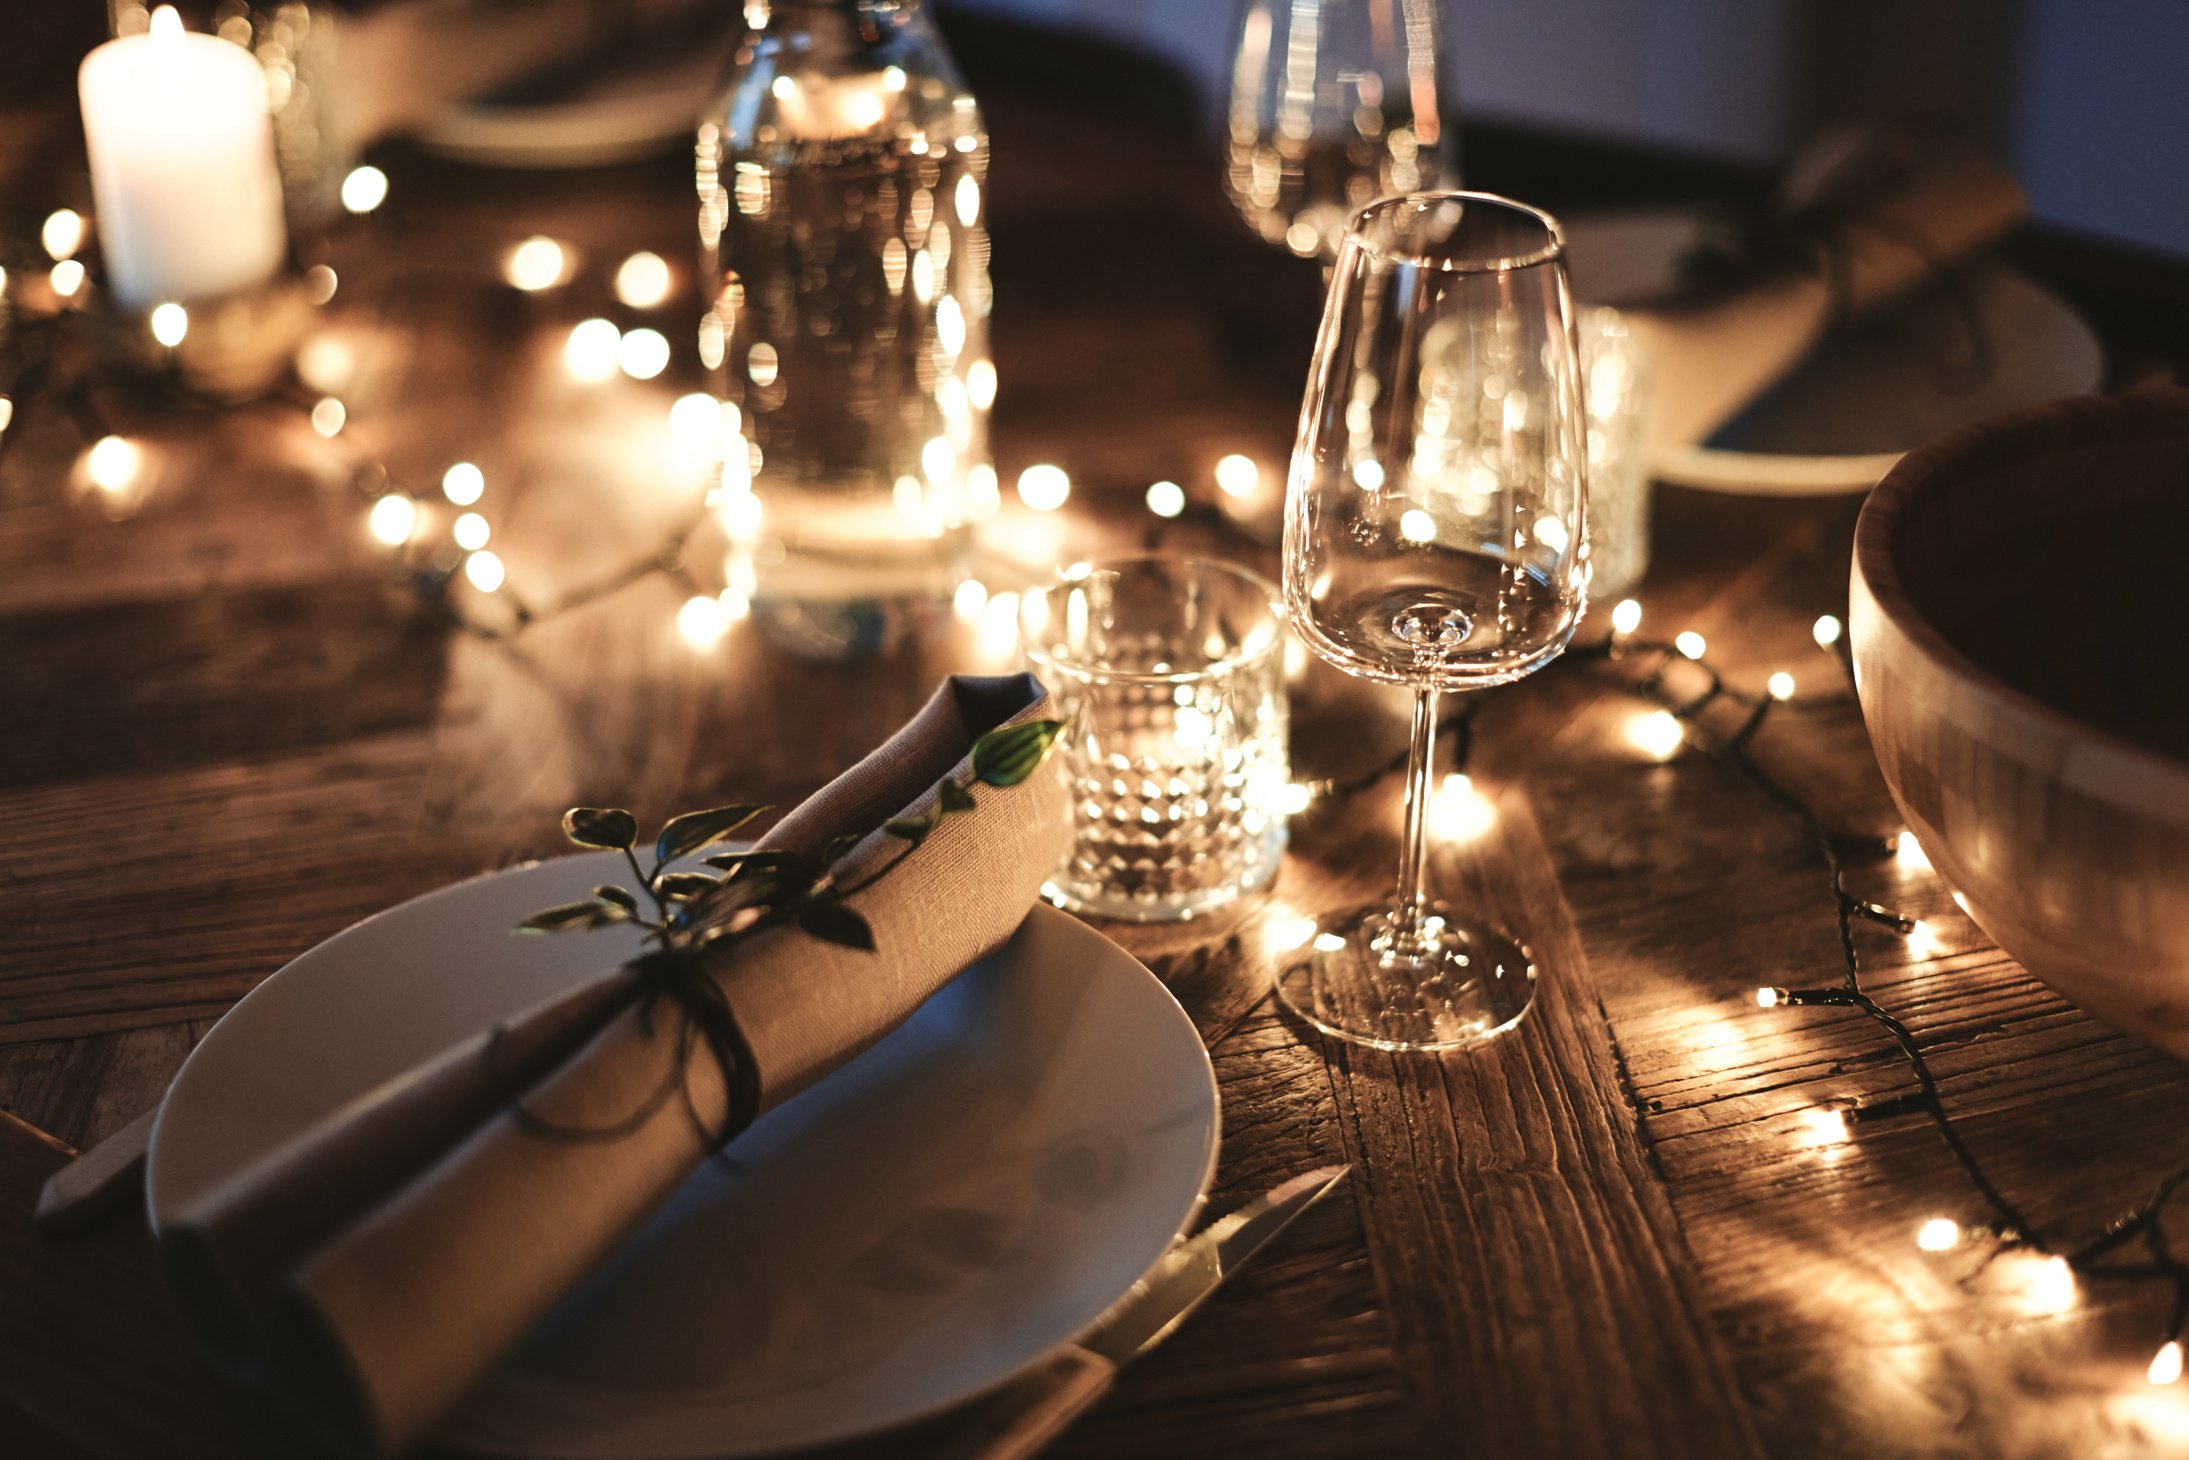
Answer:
[{"left": 1224, "top": 0, "right": 1460, "bottom": 260}]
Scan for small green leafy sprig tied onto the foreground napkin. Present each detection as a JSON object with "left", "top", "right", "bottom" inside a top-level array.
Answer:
[{"left": 517, "top": 720, "right": 1064, "bottom": 952}]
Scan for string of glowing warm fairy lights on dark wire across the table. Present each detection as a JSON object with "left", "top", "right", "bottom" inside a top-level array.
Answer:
[{"left": 0, "top": 166, "right": 2189, "bottom": 1386}]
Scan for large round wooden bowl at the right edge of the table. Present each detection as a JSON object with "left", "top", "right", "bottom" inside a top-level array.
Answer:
[{"left": 1850, "top": 392, "right": 2189, "bottom": 1055}]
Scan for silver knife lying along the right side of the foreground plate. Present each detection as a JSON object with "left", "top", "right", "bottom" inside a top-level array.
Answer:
[{"left": 946, "top": 1167, "right": 1351, "bottom": 1460}]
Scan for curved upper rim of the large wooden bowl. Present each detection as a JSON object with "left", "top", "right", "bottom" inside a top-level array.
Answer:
[{"left": 1854, "top": 390, "right": 2189, "bottom": 795}]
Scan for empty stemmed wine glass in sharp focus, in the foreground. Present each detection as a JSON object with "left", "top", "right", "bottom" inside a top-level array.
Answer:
[{"left": 1278, "top": 193, "right": 1587, "bottom": 1048}]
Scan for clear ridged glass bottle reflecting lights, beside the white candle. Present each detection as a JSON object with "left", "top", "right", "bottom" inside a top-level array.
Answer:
[{"left": 696, "top": 0, "right": 996, "bottom": 657}]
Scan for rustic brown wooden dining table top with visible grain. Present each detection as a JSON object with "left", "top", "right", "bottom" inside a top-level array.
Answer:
[{"left": 0, "top": 17, "right": 2189, "bottom": 1458}]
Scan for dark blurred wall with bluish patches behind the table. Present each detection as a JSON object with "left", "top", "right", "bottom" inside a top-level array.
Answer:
[{"left": 943, "top": 0, "right": 2189, "bottom": 254}]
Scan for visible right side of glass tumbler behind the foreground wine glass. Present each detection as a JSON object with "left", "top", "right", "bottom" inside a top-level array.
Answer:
[{"left": 1580, "top": 309, "right": 1651, "bottom": 604}]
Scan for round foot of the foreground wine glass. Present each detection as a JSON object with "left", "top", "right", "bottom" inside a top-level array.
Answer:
[{"left": 1276, "top": 902, "right": 1537, "bottom": 1051}]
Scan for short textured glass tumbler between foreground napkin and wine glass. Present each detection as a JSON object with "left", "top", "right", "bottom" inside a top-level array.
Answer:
[{"left": 1018, "top": 556, "right": 1292, "bottom": 922}]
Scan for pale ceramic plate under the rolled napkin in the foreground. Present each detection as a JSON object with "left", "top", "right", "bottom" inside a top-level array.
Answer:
[{"left": 147, "top": 854, "right": 1217, "bottom": 1458}]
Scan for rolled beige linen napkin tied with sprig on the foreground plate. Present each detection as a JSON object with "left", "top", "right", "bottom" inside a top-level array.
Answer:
[{"left": 160, "top": 674, "right": 1070, "bottom": 1453}]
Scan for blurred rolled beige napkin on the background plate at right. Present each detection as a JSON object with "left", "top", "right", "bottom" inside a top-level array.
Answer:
[{"left": 1622, "top": 134, "right": 2027, "bottom": 466}]
